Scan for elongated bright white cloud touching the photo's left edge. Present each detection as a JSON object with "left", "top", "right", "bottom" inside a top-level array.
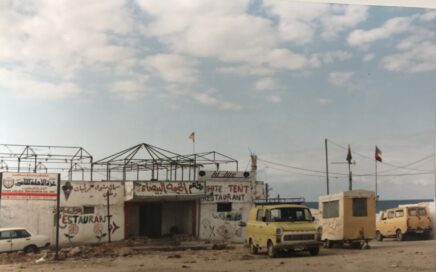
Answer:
[{"left": 0, "top": 68, "right": 83, "bottom": 100}]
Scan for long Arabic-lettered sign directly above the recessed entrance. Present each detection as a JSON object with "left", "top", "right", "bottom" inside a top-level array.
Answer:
[{"left": 133, "top": 181, "right": 206, "bottom": 197}]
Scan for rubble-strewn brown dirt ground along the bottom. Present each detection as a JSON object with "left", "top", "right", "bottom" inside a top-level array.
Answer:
[{"left": 0, "top": 240, "right": 436, "bottom": 272}]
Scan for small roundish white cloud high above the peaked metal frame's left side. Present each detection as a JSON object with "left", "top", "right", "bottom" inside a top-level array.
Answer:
[{"left": 109, "top": 80, "right": 146, "bottom": 101}]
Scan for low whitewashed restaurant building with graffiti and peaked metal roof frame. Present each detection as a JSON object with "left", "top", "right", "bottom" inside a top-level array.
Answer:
[{"left": 0, "top": 144, "right": 264, "bottom": 245}]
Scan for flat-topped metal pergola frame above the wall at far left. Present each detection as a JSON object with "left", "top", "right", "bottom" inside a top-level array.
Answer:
[{"left": 0, "top": 144, "right": 93, "bottom": 181}]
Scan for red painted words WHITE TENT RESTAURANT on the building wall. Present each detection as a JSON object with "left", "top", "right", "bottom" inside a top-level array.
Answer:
[{"left": 203, "top": 182, "right": 251, "bottom": 202}]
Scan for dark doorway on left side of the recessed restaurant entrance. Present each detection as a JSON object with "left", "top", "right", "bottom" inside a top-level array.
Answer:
[{"left": 139, "top": 203, "right": 162, "bottom": 238}]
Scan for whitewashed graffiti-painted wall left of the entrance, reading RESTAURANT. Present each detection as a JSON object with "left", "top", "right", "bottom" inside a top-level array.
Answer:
[{"left": 0, "top": 181, "right": 124, "bottom": 245}]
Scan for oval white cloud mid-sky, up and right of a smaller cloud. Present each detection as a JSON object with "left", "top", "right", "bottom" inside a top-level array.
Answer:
[{"left": 143, "top": 54, "right": 198, "bottom": 83}]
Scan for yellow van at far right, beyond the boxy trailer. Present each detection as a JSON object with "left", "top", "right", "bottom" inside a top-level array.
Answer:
[{"left": 376, "top": 206, "right": 432, "bottom": 241}]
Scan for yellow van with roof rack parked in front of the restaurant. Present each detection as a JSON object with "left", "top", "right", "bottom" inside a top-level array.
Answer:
[{"left": 240, "top": 198, "right": 321, "bottom": 257}]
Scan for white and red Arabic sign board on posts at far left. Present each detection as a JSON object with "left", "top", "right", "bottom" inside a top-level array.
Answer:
[{"left": 0, "top": 173, "right": 57, "bottom": 200}]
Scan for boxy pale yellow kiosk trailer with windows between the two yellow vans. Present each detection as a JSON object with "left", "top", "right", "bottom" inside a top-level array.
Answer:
[{"left": 319, "top": 190, "right": 376, "bottom": 248}]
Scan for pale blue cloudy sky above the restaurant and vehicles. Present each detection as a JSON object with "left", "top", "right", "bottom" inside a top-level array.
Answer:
[{"left": 0, "top": 0, "right": 436, "bottom": 200}]
